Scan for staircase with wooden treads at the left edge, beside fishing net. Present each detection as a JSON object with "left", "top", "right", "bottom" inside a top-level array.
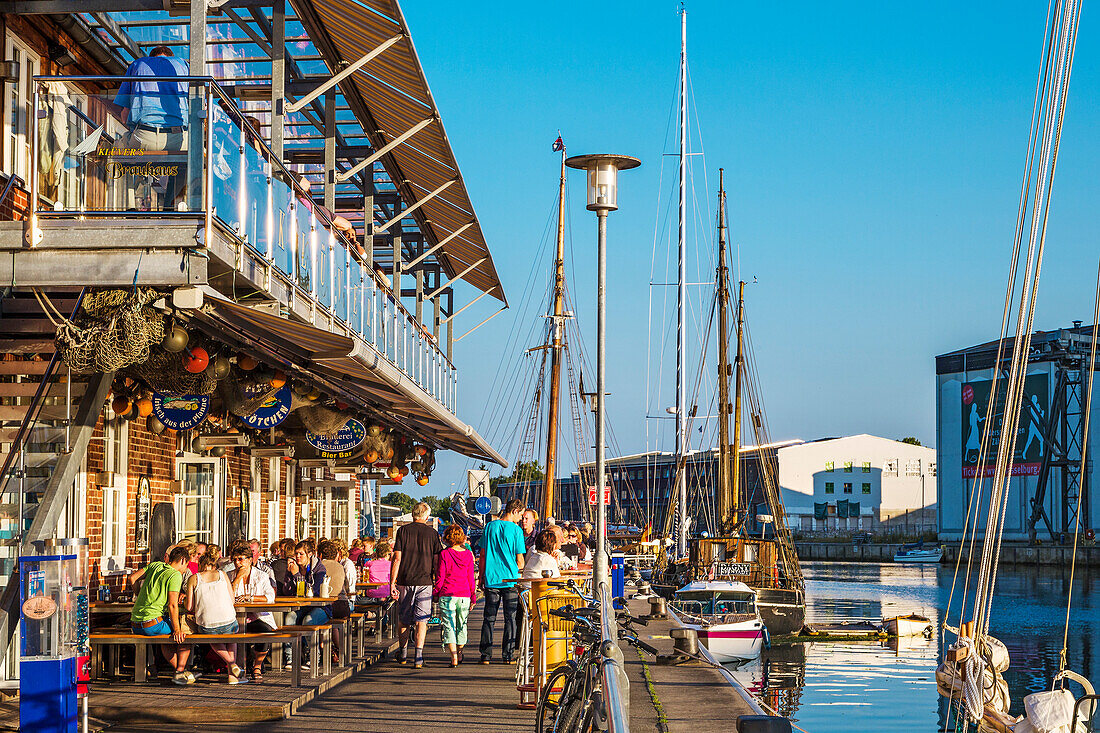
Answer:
[{"left": 0, "top": 293, "right": 113, "bottom": 688}]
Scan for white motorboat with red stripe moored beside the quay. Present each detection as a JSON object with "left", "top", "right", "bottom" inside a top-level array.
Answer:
[{"left": 672, "top": 580, "right": 768, "bottom": 663}]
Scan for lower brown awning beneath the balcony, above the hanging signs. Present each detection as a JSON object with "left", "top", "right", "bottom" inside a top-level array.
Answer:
[{"left": 197, "top": 293, "right": 507, "bottom": 466}]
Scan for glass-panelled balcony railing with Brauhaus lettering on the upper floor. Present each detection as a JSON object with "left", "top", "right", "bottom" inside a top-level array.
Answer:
[{"left": 31, "top": 76, "right": 458, "bottom": 413}]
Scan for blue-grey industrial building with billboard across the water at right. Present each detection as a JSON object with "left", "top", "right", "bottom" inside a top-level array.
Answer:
[{"left": 936, "top": 321, "right": 1097, "bottom": 544}]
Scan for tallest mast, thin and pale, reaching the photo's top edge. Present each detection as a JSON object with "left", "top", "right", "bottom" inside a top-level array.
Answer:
[{"left": 677, "top": 8, "right": 688, "bottom": 557}]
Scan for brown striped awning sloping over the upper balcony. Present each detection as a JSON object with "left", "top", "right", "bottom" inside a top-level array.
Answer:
[{"left": 301, "top": 0, "right": 507, "bottom": 303}]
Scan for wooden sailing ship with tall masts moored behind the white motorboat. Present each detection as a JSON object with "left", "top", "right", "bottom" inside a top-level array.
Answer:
[{"left": 653, "top": 10, "right": 805, "bottom": 634}]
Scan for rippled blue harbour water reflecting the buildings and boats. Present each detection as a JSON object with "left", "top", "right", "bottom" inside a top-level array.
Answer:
[{"left": 733, "top": 562, "right": 1100, "bottom": 733}]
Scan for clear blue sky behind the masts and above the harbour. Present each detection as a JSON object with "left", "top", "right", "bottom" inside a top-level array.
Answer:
[{"left": 404, "top": 0, "right": 1100, "bottom": 494}]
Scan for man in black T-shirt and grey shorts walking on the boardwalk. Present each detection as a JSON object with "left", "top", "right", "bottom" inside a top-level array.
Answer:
[{"left": 389, "top": 502, "right": 443, "bottom": 669}]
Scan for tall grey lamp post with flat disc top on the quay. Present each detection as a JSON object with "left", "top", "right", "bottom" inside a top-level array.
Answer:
[{"left": 565, "top": 153, "right": 641, "bottom": 597}]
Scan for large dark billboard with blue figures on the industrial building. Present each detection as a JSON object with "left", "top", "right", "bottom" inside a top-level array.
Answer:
[{"left": 961, "top": 374, "right": 1049, "bottom": 479}]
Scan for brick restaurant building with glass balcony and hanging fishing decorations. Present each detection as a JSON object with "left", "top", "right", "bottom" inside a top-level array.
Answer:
[{"left": 0, "top": 0, "right": 507, "bottom": 686}]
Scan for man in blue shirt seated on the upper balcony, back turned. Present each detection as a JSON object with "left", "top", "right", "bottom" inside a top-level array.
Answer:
[{"left": 114, "top": 46, "right": 190, "bottom": 209}]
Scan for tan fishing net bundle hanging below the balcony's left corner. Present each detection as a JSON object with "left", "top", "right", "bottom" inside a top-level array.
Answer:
[{"left": 56, "top": 287, "right": 164, "bottom": 374}]
